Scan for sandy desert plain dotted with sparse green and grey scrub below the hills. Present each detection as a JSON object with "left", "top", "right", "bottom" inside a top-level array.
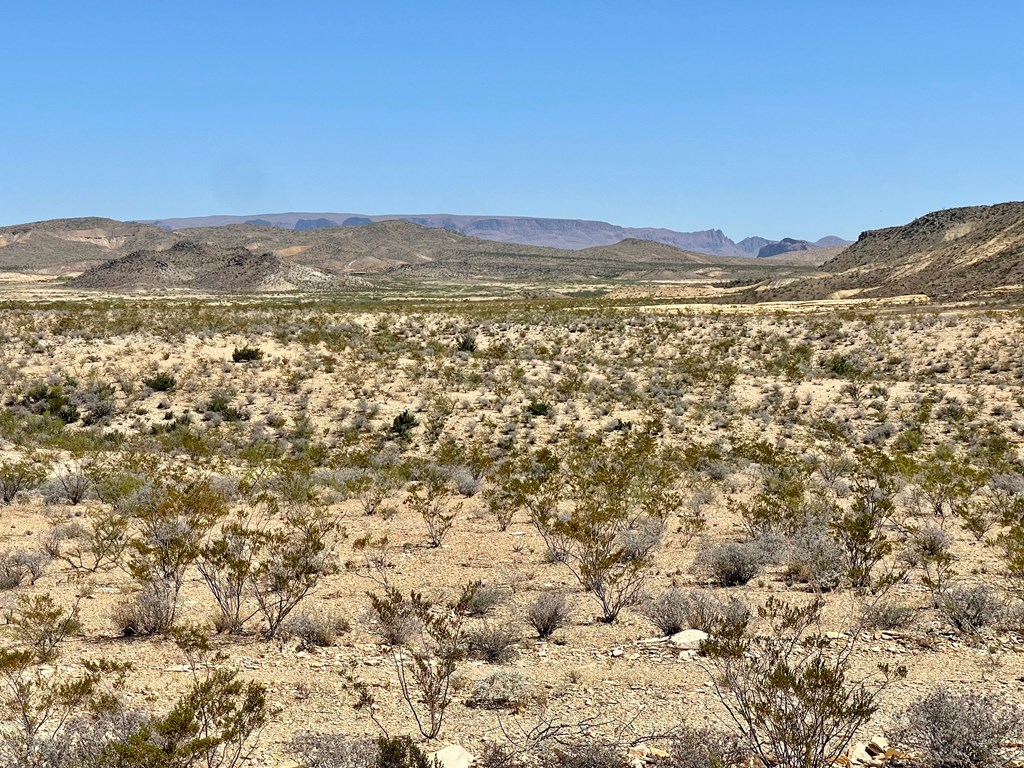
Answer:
[{"left": 0, "top": 292, "right": 1024, "bottom": 768}]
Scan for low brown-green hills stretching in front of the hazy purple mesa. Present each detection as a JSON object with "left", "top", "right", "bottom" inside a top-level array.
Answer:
[{"left": 0, "top": 218, "right": 823, "bottom": 292}]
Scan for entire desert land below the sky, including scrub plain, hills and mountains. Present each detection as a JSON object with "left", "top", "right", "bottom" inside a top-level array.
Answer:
[{"left": 0, "top": 203, "right": 1024, "bottom": 768}]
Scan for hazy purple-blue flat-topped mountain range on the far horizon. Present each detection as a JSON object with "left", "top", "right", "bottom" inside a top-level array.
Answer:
[{"left": 144, "top": 213, "right": 851, "bottom": 257}]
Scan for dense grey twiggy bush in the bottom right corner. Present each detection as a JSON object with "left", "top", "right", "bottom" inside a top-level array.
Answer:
[{"left": 890, "top": 688, "right": 1024, "bottom": 768}]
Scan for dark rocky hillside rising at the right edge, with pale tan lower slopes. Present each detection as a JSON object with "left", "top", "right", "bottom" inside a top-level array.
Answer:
[{"left": 743, "top": 203, "right": 1024, "bottom": 301}]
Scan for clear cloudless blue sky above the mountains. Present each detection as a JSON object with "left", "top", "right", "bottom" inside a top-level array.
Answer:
[{"left": 0, "top": 0, "right": 1024, "bottom": 239}]
